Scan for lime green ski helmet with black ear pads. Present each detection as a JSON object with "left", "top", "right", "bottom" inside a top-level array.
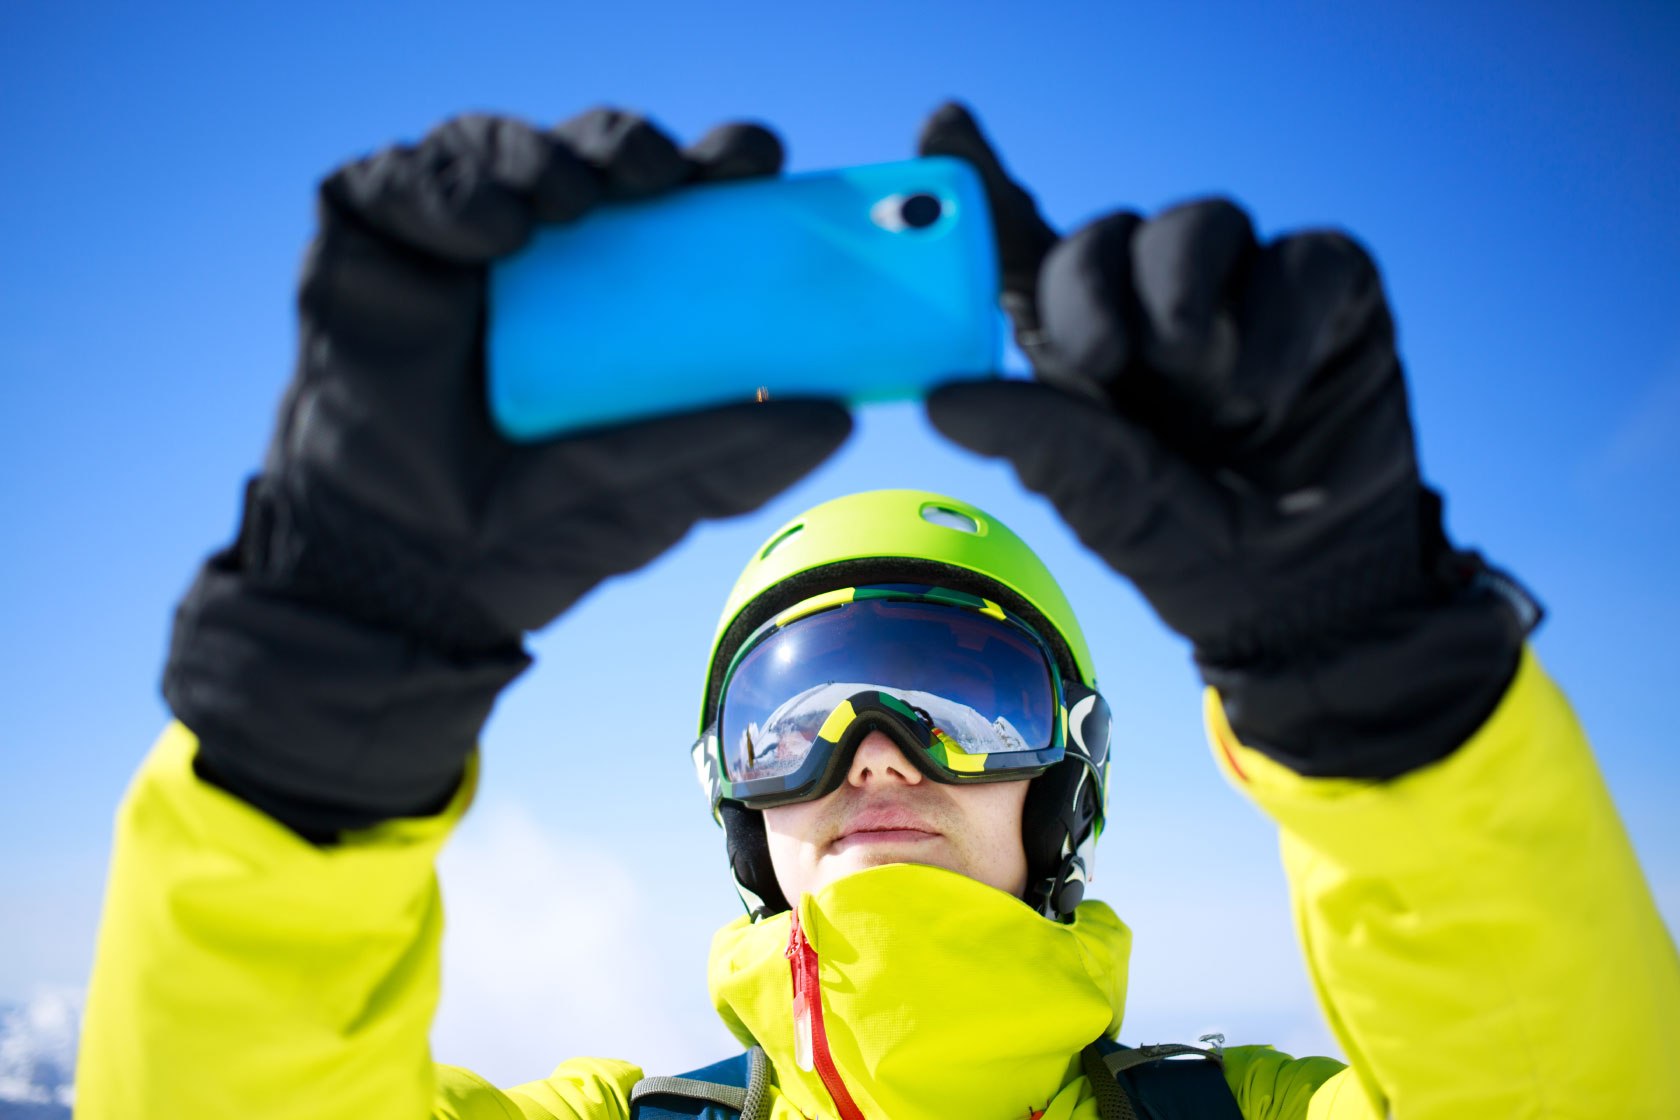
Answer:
[{"left": 701, "top": 490, "right": 1107, "bottom": 919}]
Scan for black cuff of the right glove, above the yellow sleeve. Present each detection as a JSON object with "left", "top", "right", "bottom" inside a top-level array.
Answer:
[{"left": 1198, "top": 552, "right": 1542, "bottom": 779}]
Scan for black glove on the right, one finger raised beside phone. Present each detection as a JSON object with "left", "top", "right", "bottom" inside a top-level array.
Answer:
[{"left": 922, "top": 106, "right": 1537, "bottom": 777}]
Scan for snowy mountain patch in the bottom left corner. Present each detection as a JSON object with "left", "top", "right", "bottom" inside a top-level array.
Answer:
[{"left": 0, "top": 991, "right": 82, "bottom": 1120}]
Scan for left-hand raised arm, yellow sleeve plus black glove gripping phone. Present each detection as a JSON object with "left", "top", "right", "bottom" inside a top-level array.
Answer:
[{"left": 77, "top": 109, "right": 850, "bottom": 1120}]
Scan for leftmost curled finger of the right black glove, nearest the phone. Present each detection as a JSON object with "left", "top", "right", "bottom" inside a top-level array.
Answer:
[{"left": 1037, "top": 212, "right": 1142, "bottom": 396}]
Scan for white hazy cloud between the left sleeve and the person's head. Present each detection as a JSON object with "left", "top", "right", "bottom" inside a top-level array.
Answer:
[{"left": 432, "top": 803, "right": 736, "bottom": 1085}]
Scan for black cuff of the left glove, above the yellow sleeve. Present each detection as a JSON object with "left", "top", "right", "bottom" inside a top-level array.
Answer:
[{"left": 163, "top": 549, "right": 531, "bottom": 843}]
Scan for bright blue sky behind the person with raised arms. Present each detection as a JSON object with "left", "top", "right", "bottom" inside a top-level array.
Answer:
[{"left": 0, "top": 0, "right": 1680, "bottom": 1078}]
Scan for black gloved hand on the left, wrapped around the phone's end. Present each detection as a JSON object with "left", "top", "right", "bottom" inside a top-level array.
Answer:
[{"left": 163, "top": 109, "right": 850, "bottom": 841}]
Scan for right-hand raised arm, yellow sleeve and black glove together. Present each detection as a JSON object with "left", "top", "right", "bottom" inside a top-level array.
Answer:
[{"left": 924, "top": 107, "right": 1680, "bottom": 1120}]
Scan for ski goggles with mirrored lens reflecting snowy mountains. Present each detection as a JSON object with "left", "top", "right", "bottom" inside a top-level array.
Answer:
[{"left": 694, "top": 584, "right": 1109, "bottom": 809}]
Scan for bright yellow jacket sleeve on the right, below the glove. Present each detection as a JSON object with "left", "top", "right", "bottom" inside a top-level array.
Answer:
[{"left": 1206, "top": 652, "right": 1680, "bottom": 1120}]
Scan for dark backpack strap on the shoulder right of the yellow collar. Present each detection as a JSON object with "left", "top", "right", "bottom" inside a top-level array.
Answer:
[{"left": 1080, "top": 1038, "right": 1242, "bottom": 1120}]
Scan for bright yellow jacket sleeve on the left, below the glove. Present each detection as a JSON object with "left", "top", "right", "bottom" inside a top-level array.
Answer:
[{"left": 76, "top": 724, "right": 640, "bottom": 1120}]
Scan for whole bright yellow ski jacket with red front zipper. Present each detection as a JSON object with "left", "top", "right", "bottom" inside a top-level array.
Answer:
[{"left": 77, "top": 657, "right": 1680, "bottom": 1120}]
